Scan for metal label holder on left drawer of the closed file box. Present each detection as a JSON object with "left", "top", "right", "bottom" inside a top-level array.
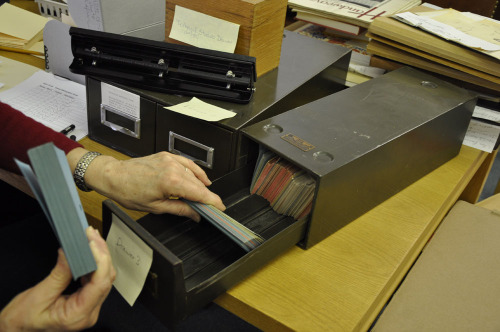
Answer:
[{"left": 101, "top": 104, "right": 141, "bottom": 139}]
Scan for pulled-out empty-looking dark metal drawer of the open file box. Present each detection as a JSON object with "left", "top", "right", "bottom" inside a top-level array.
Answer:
[{"left": 103, "top": 170, "right": 305, "bottom": 327}]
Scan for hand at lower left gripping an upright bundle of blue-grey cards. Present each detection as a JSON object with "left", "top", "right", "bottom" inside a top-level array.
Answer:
[{"left": 0, "top": 227, "right": 116, "bottom": 331}]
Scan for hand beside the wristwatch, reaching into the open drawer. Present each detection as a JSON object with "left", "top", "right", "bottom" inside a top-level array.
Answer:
[{"left": 80, "top": 152, "right": 225, "bottom": 221}]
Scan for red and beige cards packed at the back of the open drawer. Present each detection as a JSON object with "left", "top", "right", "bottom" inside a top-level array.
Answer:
[{"left": 250, "top": 149, "right": 316, "bottom": 219}]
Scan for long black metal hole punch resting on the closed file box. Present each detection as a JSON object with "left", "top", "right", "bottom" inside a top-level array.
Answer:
[{"left": 70, "top": 27, "right": 257, "bottom": 103}]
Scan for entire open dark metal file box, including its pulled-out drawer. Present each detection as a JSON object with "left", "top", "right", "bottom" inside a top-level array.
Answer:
[{"left": 103, "top": 68, "right": 476, "bottom": 324}]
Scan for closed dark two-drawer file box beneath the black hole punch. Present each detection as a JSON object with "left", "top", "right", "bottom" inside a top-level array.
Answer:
[{"left": 87, "top": 31, "right": 350, "bottom": 179}]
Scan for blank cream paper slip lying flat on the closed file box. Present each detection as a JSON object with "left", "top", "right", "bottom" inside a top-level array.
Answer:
[{"left": 164, "top": 97, "right": 236, "bottom": 121}]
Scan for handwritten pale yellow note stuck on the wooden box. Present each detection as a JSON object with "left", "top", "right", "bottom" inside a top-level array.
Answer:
[{"left": 169, "top": 5, "right": 240, "bottom": 53}]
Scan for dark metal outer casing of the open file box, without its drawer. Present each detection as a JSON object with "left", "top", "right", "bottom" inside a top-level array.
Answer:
[{"left": 242, "top": 68, "right": 476, "bottom": 247}]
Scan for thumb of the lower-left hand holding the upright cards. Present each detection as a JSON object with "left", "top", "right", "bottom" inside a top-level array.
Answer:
[{"left": 39, "top": 248, "right": 72, "bottom": 300}]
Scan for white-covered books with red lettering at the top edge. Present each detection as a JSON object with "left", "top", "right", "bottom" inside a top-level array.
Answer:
[{"left": 288, "top": 0, "right": 421, "bottom": 36}]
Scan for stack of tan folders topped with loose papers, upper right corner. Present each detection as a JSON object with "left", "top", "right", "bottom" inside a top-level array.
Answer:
[{"left": 367, "top": 6, "right": 500, "bottom": 98}]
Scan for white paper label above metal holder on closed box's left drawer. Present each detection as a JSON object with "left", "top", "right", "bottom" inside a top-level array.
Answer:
[{"left": 101, "top": 83, "right": 141, "bottom": 119}]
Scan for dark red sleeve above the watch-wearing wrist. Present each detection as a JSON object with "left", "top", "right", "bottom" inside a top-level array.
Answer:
[{"left": 0, "top": 102, "right": 82, "bottom": 174}]
